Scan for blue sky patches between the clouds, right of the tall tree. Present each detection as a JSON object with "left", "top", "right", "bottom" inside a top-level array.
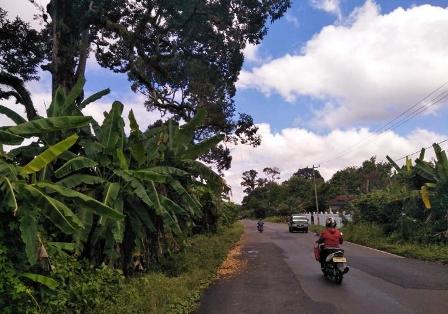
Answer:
[{"left": 235, "top": 0, "right": 448, "bottom": 134}]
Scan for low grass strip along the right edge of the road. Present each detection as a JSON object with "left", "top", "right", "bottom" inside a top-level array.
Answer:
[{"left": 309, "top": 223, "right": 448, "bottom": 264}]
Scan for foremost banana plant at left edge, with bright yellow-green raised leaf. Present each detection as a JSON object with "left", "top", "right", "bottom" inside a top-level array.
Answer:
[{"left": 0, "top": 134, "right": 123, "bottom": 265}]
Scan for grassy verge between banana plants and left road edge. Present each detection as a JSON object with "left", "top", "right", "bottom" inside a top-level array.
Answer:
[{"left": 103, "top": 223, "right": 243, "bottom": 313}]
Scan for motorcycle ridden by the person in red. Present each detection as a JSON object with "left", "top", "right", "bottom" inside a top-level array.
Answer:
[{"left": 314, "top": 244, "right": 349, "bottom": 284}]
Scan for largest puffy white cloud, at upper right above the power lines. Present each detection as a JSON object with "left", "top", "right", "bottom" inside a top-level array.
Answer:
[{"left": 238, "top": 1, "right": 448, "bottom": 128}]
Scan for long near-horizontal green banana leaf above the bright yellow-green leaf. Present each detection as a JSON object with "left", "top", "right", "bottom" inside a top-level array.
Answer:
[{"left": 7, "top": 116, "right": 91, "bottom": 137}]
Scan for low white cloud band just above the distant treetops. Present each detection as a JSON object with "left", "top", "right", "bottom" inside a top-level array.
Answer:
[{"left": 225, "top": 124, "right": 447, "bottom": 202}]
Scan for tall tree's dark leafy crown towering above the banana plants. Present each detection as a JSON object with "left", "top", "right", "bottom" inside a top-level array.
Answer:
[{"left": 0, "top": 0, "right": 290, "bottom": 170}]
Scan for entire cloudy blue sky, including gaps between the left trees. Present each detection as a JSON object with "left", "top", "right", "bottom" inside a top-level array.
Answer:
[{"left": 0, "top": 0, "right": 448, "bottom": 202}]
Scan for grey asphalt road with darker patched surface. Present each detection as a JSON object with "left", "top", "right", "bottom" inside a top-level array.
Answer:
[{"left": 199, "top": 221, "right": 448, "bottom": 314}]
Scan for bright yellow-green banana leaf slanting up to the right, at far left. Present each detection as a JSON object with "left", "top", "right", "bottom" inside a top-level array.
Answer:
[{"left": 21, "top": 134, "right": 78, "bottom": 175}]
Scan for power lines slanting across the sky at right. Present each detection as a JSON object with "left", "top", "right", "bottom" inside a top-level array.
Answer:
[{"left": 320, "top": 81, "right": 448, "bottom": 164}]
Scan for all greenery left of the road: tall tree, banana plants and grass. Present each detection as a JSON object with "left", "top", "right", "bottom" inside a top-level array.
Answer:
[{"left": 0, "top": 0, "right": 290, "bottom": 313}]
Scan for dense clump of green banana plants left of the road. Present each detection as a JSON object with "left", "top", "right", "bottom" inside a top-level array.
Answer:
[{"left": 0, "top": 79, "right": 238, "bottom": 312}]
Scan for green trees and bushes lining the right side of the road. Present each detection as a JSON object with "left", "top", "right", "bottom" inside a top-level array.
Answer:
[{"left": 242, "top": 148, "right": 448, "bottom": 263}]
